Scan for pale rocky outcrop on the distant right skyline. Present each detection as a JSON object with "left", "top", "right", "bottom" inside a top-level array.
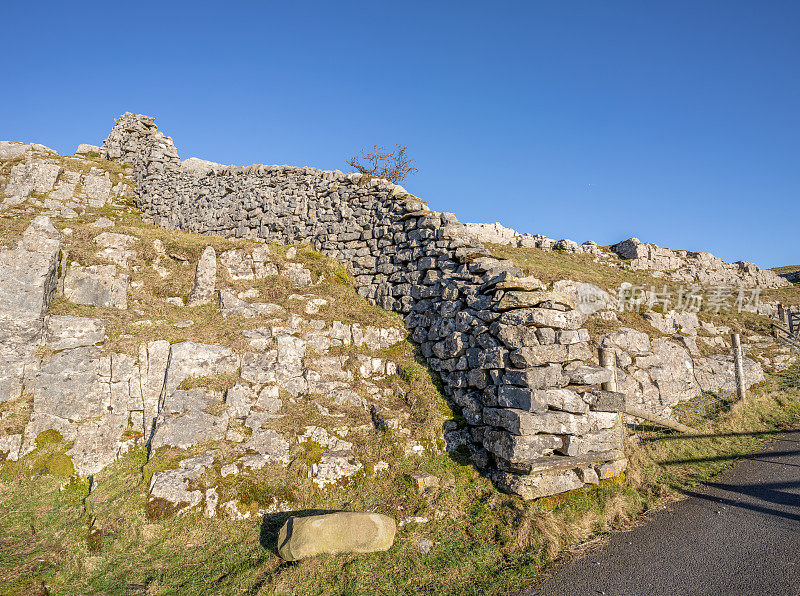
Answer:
[{"left": 611, "top": 238, "right": 789, "bottom": 288}]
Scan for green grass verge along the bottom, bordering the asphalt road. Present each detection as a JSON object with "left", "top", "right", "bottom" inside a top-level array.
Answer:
[{"left": 0, "top": 384, "right": 800, "bottom": 594}]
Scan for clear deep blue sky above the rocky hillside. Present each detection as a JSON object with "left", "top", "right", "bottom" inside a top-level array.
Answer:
[{"left": 0, "top": 0, "right": 800, "bottom": 267}]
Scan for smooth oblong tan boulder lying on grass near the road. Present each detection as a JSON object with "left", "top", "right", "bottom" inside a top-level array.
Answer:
[{"left": 278, "top": 512, "right": 396, "bottom": 561}]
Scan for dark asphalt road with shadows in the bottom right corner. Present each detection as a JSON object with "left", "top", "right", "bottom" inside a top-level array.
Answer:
[{"left": 529, "top": 431, "right": 800, "bottom": 596}]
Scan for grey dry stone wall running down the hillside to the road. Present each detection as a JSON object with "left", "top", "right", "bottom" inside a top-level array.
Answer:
[{"left": 103, "top": 113, "right": 625, "bottom": 498}]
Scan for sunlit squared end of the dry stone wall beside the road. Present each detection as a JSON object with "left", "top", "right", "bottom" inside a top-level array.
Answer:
[{"left": 456, "top": 276, "right": 625, "bottom": 498}]
